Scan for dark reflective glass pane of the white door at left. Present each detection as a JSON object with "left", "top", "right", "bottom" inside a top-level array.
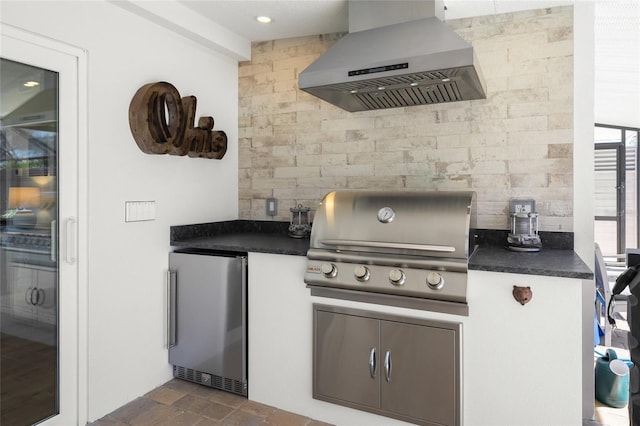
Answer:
[{"left": 0, "top": 58, "right": 58, "bottom": 425}]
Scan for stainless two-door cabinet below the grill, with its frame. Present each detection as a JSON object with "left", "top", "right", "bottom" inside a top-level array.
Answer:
[{"left": 313, "top": 305, "right": 462, "bottom": 425}]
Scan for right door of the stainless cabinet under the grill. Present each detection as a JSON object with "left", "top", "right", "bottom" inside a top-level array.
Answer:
[{"left": 380, "top": 321, "right": 460, "bottom": 425}]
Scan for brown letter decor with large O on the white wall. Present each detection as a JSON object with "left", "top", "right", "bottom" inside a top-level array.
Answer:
[{"left": 129, "top": 81, "right": 227, "bottom": 160}]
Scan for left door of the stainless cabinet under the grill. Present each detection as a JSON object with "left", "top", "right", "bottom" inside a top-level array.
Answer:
[{"left": 313, "top": 311, "right": 380, "bottom": 408}]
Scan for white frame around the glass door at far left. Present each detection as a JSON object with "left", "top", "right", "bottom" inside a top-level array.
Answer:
[{"left": 0, "top": 23, "right": 88, "bottom": 426}]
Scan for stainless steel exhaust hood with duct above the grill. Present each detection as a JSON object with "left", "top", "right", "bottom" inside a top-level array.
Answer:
[{"left": 298, "top": 1, "right": 486, "bottom": 112}]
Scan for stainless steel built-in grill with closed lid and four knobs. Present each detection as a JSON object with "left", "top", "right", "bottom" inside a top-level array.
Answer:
[{"left": 305, "top": 191, "right": 476, "bottom": 315}]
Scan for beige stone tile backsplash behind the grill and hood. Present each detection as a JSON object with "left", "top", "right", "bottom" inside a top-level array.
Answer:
[{"left": 239, "top": 6, "right": 573, "bottom": 232}]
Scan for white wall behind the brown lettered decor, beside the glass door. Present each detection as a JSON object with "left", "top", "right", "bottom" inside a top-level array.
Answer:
[{"left": 1, "top": 1, "right": 238, "bottom": 421}]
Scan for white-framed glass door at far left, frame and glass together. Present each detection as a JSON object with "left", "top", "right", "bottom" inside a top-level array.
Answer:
[{"left": 0, "top": 25, "right": 79, "bottom": 426}]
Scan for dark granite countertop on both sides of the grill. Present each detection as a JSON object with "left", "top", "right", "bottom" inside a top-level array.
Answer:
[{"left": 170, "top": 220, "right": 593, "bottom": 279}]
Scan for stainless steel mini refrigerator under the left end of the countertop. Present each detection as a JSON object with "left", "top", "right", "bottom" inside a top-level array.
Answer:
[{"left": 167, "top": 250, "right": 248, "bottom": 396}]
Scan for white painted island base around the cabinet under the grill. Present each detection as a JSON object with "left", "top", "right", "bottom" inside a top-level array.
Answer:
[{"left": 248, "top": 253, "right": 592, "bottom": 426}]
